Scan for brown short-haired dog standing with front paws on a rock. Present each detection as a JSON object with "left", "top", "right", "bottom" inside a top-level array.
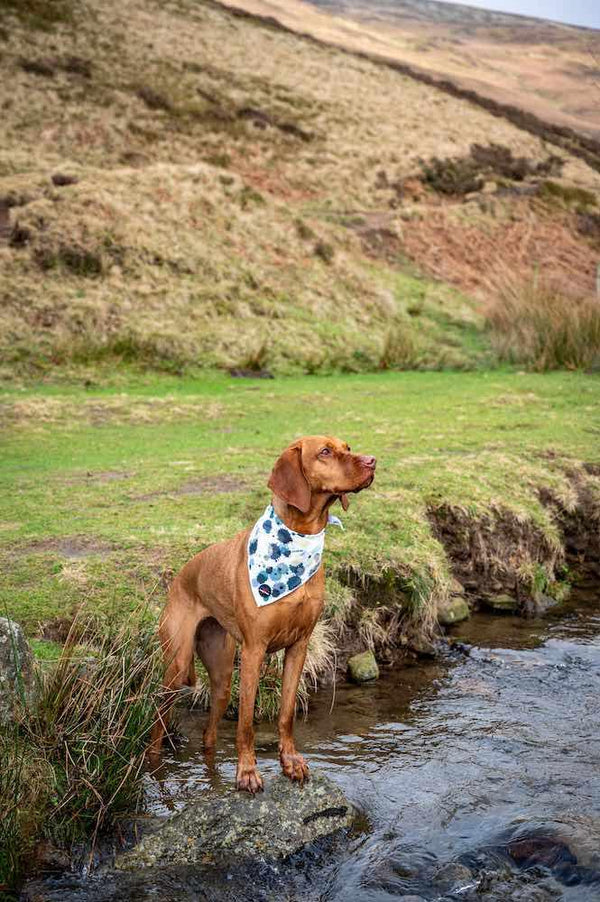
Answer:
[{"left": 149, "top": 435, "right": 376, "bottom": 793}]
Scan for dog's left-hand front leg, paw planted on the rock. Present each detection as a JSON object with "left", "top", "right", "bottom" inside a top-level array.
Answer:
[{"left": 235, "top": 643, "right": 265, "bottom": 794}]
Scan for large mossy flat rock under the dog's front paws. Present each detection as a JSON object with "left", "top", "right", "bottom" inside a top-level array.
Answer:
[{"left": 115, "top": 773, "right": 356, "bottom": 871}]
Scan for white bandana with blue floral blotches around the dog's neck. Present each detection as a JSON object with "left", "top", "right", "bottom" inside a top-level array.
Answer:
[{"left": 248, "top": 504, "right": 343, "bottom": 607}]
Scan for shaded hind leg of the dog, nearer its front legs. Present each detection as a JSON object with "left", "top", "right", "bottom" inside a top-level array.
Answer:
[{"left": 196, "top": 617, "right": 235, "bottom": 755}]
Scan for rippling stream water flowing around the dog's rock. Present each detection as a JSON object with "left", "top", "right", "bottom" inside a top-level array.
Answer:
[{"left": 25, "top": 599, "right": 600, "bottom": 902}]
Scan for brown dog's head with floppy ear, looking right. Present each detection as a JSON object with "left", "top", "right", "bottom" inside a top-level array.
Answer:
[{"left": 268, "top": 435, "right": 377, "bottom": 514}]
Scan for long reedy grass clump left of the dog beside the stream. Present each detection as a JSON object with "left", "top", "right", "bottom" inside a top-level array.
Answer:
[{"left": 0, "top": 616, "right": 162, "bottom": 886}]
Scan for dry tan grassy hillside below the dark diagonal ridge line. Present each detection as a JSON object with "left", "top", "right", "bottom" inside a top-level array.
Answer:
[{"left": 0, "top": 0, "right": 600, "bottom": 378}]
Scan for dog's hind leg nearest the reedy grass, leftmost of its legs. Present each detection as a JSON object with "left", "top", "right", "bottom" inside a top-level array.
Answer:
[{"left": 148, "top": 578, "right": 209, "bottom": 766}]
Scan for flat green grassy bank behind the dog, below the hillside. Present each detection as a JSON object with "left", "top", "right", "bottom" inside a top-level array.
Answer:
[{"left": 0, "top": 372, "right": 600, "bottom": 660}]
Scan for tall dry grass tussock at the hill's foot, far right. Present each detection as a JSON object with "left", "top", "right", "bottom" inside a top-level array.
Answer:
[{"left": 486, "top": 271, "right": 600, "bottom": 370}]
